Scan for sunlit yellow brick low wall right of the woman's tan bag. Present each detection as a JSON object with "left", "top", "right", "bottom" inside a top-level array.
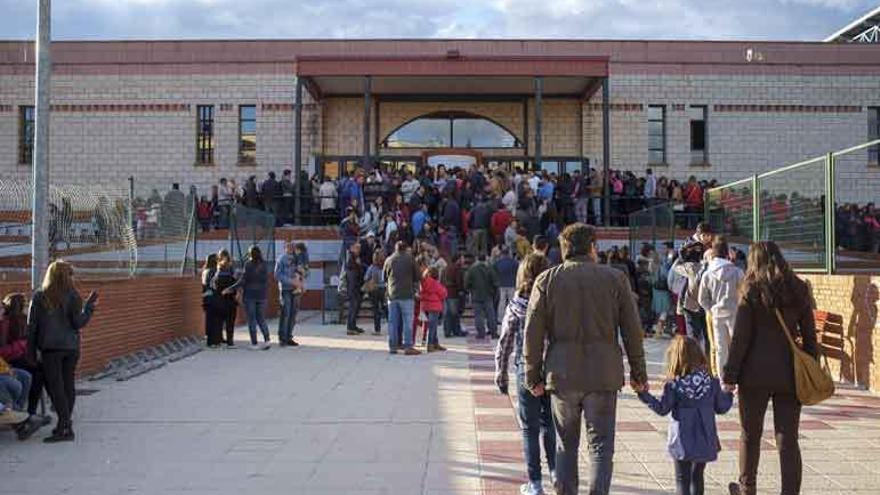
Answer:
[{"left": 801, "top": 275, "right": 880, "bottom": 392}]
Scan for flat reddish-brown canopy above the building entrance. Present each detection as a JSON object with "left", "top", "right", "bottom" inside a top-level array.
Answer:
[{"left": 296, "top": 51, "right": 608, "bottom": 99}]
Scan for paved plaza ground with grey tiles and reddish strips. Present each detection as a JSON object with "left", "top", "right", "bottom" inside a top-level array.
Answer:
[{"left": 0, "top": 315, "right": 880, "bottom": 495}]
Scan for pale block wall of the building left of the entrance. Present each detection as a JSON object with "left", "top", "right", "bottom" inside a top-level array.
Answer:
[{"left": 0, "top": 74, "right": 320, "bottom": 195}]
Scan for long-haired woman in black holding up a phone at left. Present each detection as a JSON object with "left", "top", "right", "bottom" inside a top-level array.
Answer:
[{"left": 28, "top": 260, "right": 98, "bottom": 443}]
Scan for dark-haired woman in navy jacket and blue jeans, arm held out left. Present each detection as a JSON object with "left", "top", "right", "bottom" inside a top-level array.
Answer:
[{"left": 223, "top": 246, "right": 270, "bottom": 349}]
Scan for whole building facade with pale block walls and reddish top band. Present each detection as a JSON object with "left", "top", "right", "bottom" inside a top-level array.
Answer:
[{"left": 0, "top": 40, "right": 880, "bottom": 202}]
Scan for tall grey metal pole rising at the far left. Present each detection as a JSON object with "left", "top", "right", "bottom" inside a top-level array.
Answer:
[{"left": 31, "top": 0, "right": 52, "bottom": 289}]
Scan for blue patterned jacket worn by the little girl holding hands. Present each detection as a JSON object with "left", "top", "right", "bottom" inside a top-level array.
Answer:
[{"left": 639, "top": 370, "right": 733, "bottom": 462}]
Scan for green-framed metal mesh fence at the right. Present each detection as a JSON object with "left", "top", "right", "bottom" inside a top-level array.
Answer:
[{"left": 705, "top": 140, "right": 880, "bottom": 273}]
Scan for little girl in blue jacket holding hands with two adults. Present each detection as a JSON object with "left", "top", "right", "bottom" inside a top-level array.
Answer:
[{"left": 639, "top": 335, "right": 733, "bottom": 495}]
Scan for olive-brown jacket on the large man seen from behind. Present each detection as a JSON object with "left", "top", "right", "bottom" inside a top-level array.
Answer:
[{"left": 523, "top": 256, "right": 647, "bottom": 392}]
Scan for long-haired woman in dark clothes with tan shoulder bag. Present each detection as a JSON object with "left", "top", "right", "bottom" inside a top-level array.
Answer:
[{"left": 724, "top": 241, "right": 817, "bottom": 495}]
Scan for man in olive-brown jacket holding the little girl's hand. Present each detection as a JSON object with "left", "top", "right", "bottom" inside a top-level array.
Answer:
[{"left": 523, "top": 223, "right": 648, "bottom": 495}]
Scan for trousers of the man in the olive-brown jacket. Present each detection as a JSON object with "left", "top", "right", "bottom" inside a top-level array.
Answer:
[{"left": 550, "top": 391, "right": 617, "bottom": 495}]
